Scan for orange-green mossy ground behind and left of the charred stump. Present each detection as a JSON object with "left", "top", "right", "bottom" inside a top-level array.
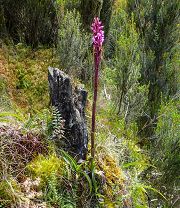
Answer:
[{"left": 0, "top": 44, "right": 58, "bottom": 112}]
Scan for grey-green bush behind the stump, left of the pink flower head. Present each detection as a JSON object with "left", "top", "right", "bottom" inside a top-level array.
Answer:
[{"left": 57, "top": 10, "right": 90, "bottom": 81}]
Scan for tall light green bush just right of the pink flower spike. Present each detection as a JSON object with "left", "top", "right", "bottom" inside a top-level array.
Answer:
[{"left": 107, "top": 6, "right": 148, "bottom": 123}]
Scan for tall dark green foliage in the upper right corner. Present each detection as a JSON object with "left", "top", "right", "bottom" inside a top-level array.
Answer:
[{"left": 128, "top": 0, "right": 179, "bottom": 118}]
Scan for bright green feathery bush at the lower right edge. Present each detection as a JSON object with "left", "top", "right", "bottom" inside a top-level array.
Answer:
[{"left": 151, "top": 98, "right": 180, "bottom": 207}]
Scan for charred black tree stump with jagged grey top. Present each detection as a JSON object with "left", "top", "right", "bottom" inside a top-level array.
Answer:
[{"left": 48, "top": 67, "right": 88, "bottom": 159}]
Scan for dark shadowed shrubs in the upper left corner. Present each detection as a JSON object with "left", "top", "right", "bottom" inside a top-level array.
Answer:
[{"left": 1, "top": 0, "right": 57, "bottom": 48}]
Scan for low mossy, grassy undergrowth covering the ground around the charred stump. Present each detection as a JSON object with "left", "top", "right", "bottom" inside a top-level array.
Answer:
[{"left": 0, "top": 44, "right": 166, "bottom": 208}]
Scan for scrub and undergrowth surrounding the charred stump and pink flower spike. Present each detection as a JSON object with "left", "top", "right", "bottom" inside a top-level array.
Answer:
[{"left": 0, "top": 0, "right": 180, "bottom": 208}]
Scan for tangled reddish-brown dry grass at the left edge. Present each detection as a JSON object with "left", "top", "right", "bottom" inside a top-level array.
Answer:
[{"left": 0, "top": 126, "right": 47, "bottom": 179}]
